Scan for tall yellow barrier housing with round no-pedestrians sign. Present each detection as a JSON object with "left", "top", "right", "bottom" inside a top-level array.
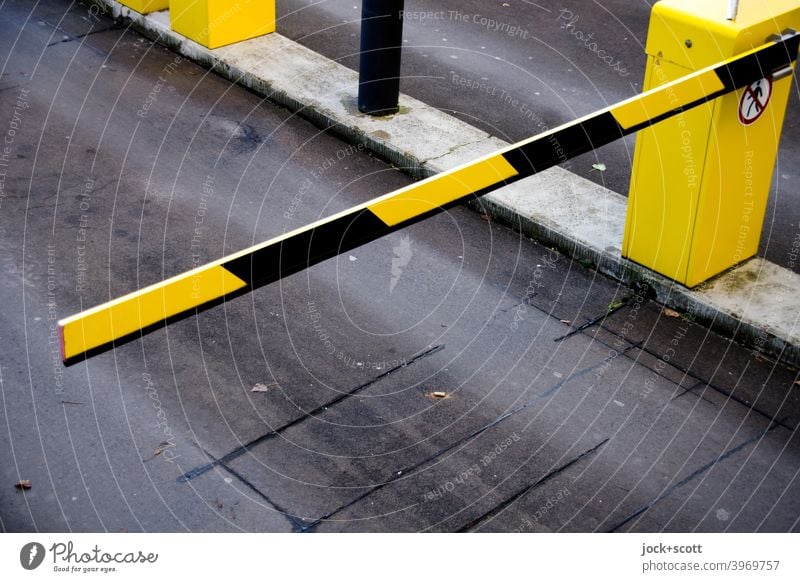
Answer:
[{"left": 622, "top": 0, "right": 800, "bottom": 287}]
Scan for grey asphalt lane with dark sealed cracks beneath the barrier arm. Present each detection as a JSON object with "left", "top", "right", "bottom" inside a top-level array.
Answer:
[{"left": 0, "top": 0, "right": 800, "bottom": 532}]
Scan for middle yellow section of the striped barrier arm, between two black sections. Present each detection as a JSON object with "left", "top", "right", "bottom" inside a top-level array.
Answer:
[{"left": 368, "top": 155, "right": 517, "bottom": 226}]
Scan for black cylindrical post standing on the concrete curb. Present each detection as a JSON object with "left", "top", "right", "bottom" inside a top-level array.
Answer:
[{"left": 358, "top": 0, "right": 404, "bottom": 115}]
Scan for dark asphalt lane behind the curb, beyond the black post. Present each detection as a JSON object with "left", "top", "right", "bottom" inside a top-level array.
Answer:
[{"left": 277, "top": 0, "right": 800, "bottom": 272}]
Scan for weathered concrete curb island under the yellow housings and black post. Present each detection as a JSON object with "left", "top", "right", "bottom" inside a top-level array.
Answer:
[{"left": 92, "top": 0, "right": 800, "bottom": 366}]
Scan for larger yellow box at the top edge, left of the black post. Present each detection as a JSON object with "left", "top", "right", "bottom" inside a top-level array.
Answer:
[{"left": 169, "top": 0, "right": 275, "bottom": 48}]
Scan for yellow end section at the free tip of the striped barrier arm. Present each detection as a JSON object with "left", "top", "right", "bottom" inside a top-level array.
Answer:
[{"left": 58, "top": 263, "right": 247, "bottom": 360}]
